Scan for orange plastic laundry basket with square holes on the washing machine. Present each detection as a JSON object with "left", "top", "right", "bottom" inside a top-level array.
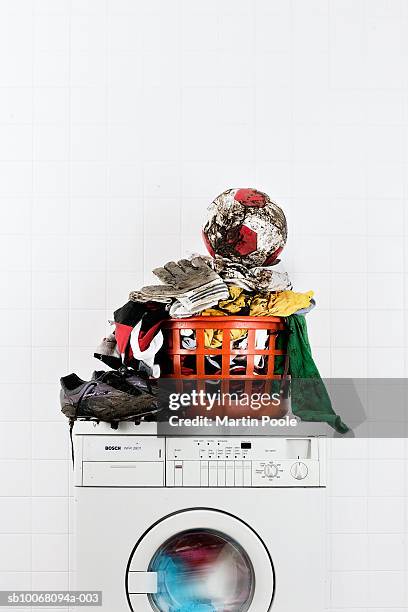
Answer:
[{"left": 161, "top": 316, "right": 288, "bottom": 418}]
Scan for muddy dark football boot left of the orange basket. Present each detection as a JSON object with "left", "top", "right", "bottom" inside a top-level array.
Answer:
[{"left": 60, "top": 373, "right": 158, "bottom": 422}]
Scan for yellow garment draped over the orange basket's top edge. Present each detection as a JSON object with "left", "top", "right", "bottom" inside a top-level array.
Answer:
[{"left": 201, "top": 285, "right": 314, "bottom": 348}]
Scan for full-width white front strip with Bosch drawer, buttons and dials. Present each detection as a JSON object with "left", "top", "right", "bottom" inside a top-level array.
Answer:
[{"left": 75, "top": 434, "right": 326, "bottom": 487}]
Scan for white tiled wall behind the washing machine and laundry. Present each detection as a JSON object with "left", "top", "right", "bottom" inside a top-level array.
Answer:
[{"left": 0, "top": 0, "right": 408, "bottom": 612}]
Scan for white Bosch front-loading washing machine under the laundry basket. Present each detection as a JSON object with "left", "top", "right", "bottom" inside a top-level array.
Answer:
[{"left": 75, "top": 422, "right": 326, "bottom": 612}]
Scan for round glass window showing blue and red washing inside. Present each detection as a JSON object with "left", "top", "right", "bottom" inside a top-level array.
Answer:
[{"left": 148, "top": 529, "right": 255, "bottom": 612}]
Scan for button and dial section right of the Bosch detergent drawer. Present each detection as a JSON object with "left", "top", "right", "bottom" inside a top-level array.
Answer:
[{"left": 166, "top": 438, "right": 324, "bottom": 487}]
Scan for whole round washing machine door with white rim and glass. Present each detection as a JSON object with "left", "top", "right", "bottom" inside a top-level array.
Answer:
[{"left": 126, "top": 509, "right": 275, "bottom": 612}]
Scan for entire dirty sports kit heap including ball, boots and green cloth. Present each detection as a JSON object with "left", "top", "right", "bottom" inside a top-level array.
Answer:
[{"left": 61, "top": 188, "right": 347, "bottom": 433}]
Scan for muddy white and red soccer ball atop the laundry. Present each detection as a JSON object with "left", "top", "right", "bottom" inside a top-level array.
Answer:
[{"left": 203, "top": 189, "right": 288, "bottom": 267}]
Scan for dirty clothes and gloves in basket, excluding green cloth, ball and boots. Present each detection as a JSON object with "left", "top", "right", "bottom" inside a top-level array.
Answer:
[{"left": 95, "top": 256, "right": 315, "bottom": 378}]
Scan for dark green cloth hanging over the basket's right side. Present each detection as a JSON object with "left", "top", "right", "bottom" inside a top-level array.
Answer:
[{"left": 276, "top": 315, "right": 349, "bottom": 434}]
